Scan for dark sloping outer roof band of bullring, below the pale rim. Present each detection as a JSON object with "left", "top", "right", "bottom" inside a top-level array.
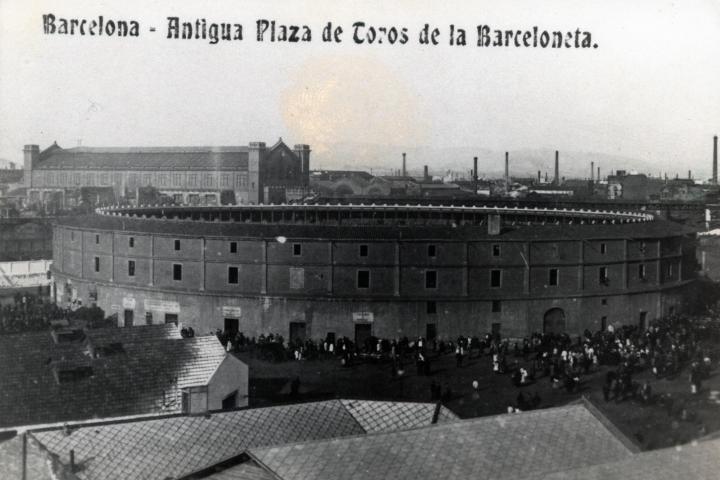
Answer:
[{"left": 57, "top": 215, "right": 692, "bottom": 241}]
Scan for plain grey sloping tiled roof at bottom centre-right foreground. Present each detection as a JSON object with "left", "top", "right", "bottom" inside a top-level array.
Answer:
[{"left": 250, "top": 405, "right": 632, "bottom": 480}]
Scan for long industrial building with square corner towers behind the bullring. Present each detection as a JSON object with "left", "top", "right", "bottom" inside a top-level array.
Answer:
[{"left": 23, "top": 139, "right": 310, "bottom": 206}]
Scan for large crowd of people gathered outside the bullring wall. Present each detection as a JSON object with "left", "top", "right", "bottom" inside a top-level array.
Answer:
[{"left": 222, "top": 316, "right": 716, "bottom": 411}]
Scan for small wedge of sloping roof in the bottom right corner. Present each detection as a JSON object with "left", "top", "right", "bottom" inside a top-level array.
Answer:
[{"left": 535, "top": 440, "right": 720, "bottom": 480}]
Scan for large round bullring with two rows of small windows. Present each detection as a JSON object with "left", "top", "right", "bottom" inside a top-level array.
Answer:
[{"left": 52, "top": 204, "right": 697, "bottom": 342}]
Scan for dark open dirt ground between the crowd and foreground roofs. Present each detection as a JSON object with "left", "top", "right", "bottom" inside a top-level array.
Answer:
[{"left": 237, "top": 353, "right": 720, "bottom": 450}]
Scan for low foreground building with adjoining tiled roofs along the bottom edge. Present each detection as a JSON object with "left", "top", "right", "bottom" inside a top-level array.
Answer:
[{"left": 0, "top": 400, "right": 720, "bottom": 480}]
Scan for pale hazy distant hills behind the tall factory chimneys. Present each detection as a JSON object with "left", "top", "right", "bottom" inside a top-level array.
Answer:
[{"left": 312, "top": 143, "right": 687, "bottom": 182}]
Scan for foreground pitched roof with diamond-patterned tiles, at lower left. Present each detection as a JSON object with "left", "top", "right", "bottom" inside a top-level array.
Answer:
[{"left": 32, "top": 400, "right": 457, "bottom": 480}]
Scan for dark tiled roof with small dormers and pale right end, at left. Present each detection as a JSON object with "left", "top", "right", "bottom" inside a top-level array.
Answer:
[{"left": 0, "top": 325, "right": 226, "bottom": 427}]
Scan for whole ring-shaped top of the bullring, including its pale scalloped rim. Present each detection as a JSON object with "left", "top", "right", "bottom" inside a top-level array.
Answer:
[{"left": 52, "top": 205, "right": 694, "bottom": 241}]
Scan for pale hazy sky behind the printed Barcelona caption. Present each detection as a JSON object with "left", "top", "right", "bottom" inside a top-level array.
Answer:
[{"left": 0, "top": 0, "right": 720, "bottom": 176}]
